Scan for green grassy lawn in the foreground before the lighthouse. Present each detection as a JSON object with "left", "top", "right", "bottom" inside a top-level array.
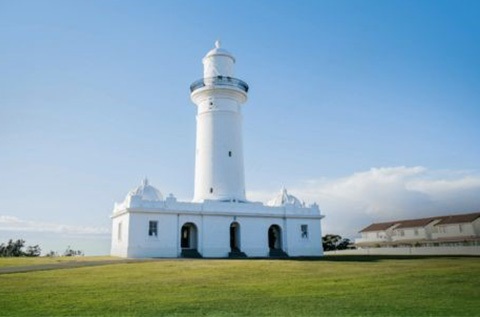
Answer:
[{"left": 0, "top": 256, "right": 480, "bottom": 316}]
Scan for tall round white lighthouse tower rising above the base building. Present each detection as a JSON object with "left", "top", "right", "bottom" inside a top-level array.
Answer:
[{"left": 190, "top": 41, "right": 248, "bottom": 202}]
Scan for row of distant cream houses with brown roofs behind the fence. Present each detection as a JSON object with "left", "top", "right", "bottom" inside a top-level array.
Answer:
[{"left": 355, "top": 212, "right": 480, "bottom": 248}]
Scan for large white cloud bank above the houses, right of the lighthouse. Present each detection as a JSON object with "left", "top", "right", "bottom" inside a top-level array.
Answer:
[{"left": 249, "top": 166, "right": 480, "bottom": 238}]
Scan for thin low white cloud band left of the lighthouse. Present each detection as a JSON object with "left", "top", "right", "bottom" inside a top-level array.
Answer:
[{"left": 0, "top": 215, "right": 110, "bottom": 235}]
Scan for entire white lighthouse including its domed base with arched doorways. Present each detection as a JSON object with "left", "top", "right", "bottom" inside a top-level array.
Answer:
[{"left": 111, "top": 41, "right": 323, "bottom": 258}]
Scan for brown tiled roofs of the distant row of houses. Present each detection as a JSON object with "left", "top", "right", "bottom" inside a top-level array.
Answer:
[{"left": 360, "top": 212, "right": 480, "bottom": 232}]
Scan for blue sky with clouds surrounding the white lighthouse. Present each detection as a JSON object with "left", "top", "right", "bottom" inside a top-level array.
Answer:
[{"left": 0, "top": 0, "right": 480, "bottom": 254}]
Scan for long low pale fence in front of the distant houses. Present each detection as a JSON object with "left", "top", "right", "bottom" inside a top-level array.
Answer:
[{"left": 324, "top": 246, "right": 480, "bottom": 255}]
